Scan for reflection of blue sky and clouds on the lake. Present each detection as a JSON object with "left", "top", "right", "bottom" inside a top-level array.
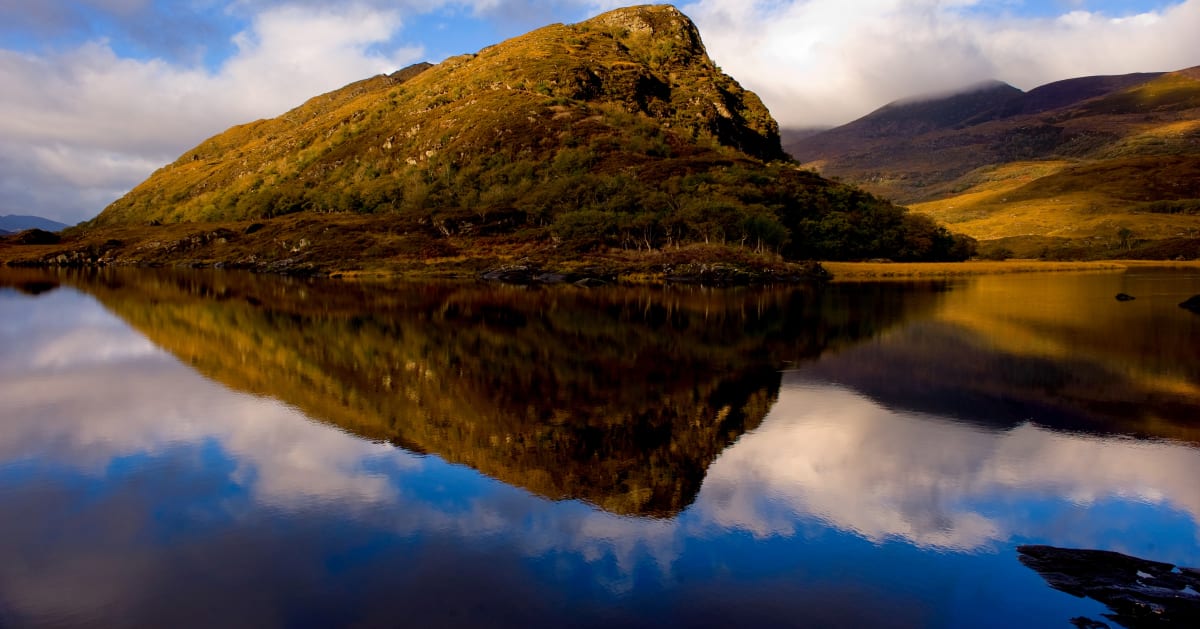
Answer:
[{"left": 0, "top": 276, "right": 1200, "bottom": 627}]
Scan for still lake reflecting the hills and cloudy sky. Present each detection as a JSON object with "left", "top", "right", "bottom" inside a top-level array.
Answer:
[{"left": 0, "top": 269, "right": 1200, "bottom": 628}]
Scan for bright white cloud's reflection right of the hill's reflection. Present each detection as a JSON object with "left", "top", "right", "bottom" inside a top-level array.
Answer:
[{"left": 697, "top": 372, "right": 1200, "bottom": 561}]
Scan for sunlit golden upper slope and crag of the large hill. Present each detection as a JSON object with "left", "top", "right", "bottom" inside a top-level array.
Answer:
[{"left": 94, "top": 6, "right": 785, "bottom": 226}]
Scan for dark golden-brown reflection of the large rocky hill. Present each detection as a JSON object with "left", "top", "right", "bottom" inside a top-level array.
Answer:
[{"left": 65, "top": 272, "right": 941, "bottom": 516}]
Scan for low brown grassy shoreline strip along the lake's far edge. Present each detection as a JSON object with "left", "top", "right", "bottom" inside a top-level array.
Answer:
[{"left": 0, "top": 215, "right": 1200, "bottom": 284}]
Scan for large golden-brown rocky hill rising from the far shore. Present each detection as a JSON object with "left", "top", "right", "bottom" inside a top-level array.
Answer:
[{"left": 0, "top": 6, "right": 968, "bottom": 274}]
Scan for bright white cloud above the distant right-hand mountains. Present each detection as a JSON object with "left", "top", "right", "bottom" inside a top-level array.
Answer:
[{"left": 682, "top": 0, "right": 1200, "bottom": 126}]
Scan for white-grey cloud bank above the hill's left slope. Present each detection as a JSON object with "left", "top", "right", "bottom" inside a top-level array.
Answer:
[{"left": 0, "top": 4, "right": 421, "bottom": 222}]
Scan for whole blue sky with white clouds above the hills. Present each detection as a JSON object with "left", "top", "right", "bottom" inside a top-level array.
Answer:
[{"left": 0, "top": 0, "right": 1200, "bottom": 223}]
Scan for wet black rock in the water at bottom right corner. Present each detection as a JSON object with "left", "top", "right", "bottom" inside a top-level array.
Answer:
[{"left": 1016, "top": 546, "right": 1200, "bottom": 628}]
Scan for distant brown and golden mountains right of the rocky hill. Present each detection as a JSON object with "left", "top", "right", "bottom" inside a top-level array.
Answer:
[{"left": 786, "top": 68, "right": 1200, "bottom": 257}]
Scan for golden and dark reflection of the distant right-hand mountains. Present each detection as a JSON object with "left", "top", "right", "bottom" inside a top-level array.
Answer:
[{"left": 804, "top": 271, "right": 1200, "bottom": 444}]
